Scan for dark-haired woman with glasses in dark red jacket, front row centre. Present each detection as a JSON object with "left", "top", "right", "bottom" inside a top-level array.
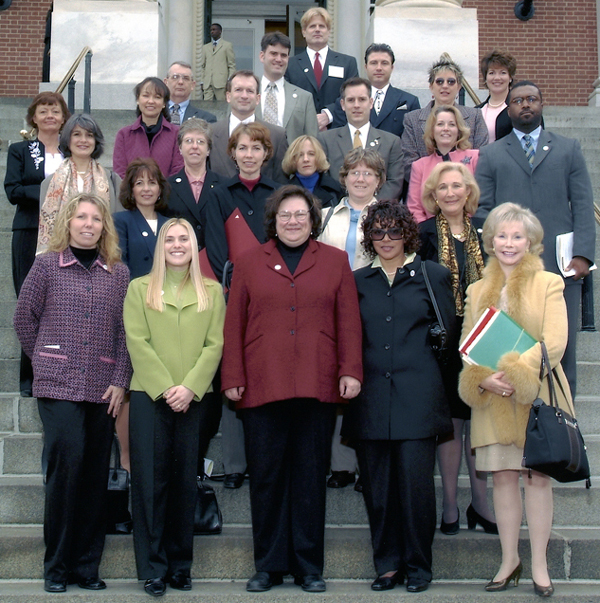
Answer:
[{"left": 222, "top": 185, "right": 362, "bottom": 592}]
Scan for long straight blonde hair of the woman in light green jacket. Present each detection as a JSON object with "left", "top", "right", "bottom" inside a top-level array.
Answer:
[{"left": 146, "top": 218, "right": 211, "bottom": 312}]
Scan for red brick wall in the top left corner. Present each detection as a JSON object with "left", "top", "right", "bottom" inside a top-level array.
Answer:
[{"left": 0, "top": 0, "right": 52, "bottom": 97}]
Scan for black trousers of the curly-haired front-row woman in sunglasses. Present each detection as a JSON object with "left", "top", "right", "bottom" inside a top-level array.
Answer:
[{"left": 356, "top": 438, "right": 436, "bottom": 581}]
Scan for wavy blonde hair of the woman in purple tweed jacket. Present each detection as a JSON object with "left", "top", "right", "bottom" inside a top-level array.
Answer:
[{"left": 48, "top": 193, "right": 121, "bottom": 268}]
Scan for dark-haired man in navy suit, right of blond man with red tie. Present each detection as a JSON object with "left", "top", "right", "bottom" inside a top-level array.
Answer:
[{"left": 332, "top": 44, "right": 421, "bottom": 136}]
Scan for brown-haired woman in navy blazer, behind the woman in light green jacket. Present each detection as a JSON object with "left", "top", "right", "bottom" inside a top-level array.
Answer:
[{"left": 113, "top": 157, "right": 170, "bottom": 279}]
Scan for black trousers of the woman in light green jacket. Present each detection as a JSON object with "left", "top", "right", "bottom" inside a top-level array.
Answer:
[{"left": 129, "top": 391, "right": 200, "bottom": 580}]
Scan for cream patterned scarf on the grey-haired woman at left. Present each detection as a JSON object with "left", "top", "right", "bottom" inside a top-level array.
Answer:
[{"left": 35, "top": 157, "right": 110, "bottom": 255}]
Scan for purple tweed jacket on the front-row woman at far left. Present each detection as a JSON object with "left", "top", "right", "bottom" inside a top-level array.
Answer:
[{"left": 13, "top": 248, "right": 131, "bottom": 403}]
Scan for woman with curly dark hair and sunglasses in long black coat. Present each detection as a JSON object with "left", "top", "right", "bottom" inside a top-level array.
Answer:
[{"left": 342, "top": 201, "right": 456, "bottom": 592}]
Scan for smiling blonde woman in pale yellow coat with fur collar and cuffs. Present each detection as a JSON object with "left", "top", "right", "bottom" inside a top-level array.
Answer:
[{"left": 459, "top": 203, "right": 573, "bottom": 597}]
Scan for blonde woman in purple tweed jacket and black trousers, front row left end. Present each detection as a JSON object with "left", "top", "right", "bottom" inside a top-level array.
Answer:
[{"left": 14, "top": 194, "right": 131, "bottom": 593}]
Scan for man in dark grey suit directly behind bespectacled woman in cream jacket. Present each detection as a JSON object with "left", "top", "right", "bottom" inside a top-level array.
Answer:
[{"left": 318, "top": 77, "right": 404, "bottom": 199}]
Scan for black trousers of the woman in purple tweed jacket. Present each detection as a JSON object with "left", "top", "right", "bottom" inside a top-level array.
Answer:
[{"left": 38, "top": 398, "right": 114, "bottom": 582}]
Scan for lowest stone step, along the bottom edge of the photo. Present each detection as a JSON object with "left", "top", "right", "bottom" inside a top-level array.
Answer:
[{"left": 0, "top": 576, "right": 600, "bottom": 603}]
